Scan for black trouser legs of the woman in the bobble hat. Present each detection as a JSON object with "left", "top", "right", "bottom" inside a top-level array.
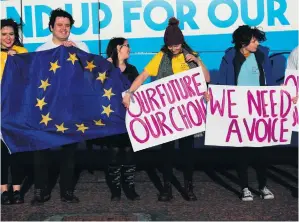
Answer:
[{"left": 161, "top": 135, "right": 194, "bottom": 182}]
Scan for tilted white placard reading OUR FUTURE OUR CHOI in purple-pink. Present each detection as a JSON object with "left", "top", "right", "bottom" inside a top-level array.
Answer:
[{"left": 126, "top": 68, "right": 207, "bottom": 152}]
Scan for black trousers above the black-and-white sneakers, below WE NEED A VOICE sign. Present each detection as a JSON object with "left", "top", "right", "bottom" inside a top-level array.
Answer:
[{"left": 237, "top": 147, "right": 268, "bottom": 189}]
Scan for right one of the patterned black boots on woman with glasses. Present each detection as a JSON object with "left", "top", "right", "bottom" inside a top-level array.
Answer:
[{"left": 122, "top": 165, "right": 140, "bottom": 200}]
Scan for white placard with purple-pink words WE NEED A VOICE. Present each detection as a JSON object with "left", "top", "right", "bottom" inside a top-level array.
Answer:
[{"left": 205, "top": 85, "right": 292, "bottom": 147}]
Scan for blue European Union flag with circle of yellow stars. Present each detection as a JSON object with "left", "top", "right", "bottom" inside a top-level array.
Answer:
[{"left": 1, "top": 46, "right": 130, "bottom": 153}]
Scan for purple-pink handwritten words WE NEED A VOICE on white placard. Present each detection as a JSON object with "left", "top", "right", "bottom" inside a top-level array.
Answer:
[{"left": 209, "top": 89, "right": 292, "bottom": 143}]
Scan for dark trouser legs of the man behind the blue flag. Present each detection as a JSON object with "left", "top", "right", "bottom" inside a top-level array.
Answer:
[{"left": 34, "top": 143, "right": 77, "bottom": 192}]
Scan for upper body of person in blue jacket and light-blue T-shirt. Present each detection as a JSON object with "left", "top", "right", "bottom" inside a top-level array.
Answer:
[{"left": 214, "top": 25, "right": 278, "bottom": 86}]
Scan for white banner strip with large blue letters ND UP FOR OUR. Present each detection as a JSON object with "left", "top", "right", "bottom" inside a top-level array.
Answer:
[{"left": 1, "top": 0, "right": 298, "bottom": 43}]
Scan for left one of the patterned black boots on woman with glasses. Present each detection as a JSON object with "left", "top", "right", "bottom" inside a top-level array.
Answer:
[{"left": 108, "top": 165, "right": 121, "bottom": 201}]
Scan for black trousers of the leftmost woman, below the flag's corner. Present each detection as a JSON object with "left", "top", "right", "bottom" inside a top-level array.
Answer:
[{"left": 1, "top": 140, "right": 25, "bottom": 185}]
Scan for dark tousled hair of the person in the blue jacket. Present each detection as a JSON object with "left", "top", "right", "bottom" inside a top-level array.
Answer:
[{"left": 232, "top": 25, "right": 267, "bottom": 49}]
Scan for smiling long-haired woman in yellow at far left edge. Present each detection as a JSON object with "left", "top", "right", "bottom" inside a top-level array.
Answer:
[{"left": 0, "top": 19, "right": 27, "bottom": 205}]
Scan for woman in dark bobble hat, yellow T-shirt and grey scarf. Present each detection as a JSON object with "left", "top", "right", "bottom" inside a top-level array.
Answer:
[{"left": 123, "top": 17, "right": 210, "bottom": 201}]
